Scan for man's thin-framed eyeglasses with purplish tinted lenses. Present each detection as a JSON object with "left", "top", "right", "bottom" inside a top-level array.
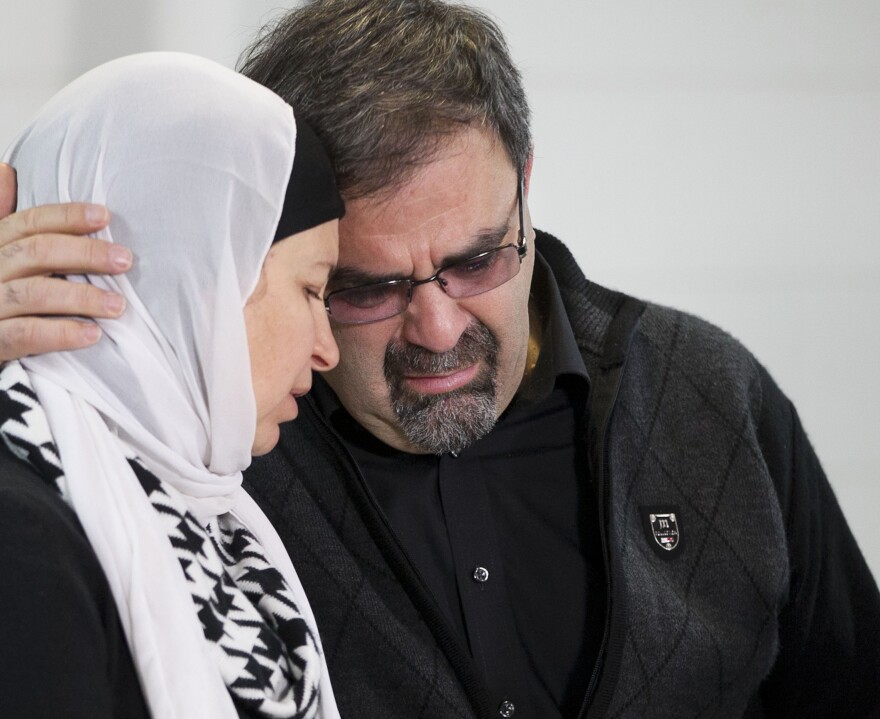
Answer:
[{"left": 324, "top": 176, "right": 528, "bottom": 325}]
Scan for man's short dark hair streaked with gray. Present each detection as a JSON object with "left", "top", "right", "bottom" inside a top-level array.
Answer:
[{"left": 239, "top": 0, "right": 531, "bottom": 198}]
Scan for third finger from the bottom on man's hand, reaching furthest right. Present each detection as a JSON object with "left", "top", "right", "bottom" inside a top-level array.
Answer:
[{"left": 0, "top": 234, "right": 132, "bottom": 282}]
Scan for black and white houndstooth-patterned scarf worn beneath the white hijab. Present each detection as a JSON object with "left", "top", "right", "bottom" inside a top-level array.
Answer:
[{"left": 0, "top": 362, "right": 321, "bottom": 719}]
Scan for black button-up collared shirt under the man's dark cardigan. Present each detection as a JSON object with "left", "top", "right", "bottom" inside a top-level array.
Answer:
[{"left": 319, "top": 255, "right": 605, "bottom": 719}]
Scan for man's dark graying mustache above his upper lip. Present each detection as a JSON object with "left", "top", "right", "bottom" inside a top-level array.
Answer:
[{"left": 383, "top": 322, "right": 498, "bottom": 380}]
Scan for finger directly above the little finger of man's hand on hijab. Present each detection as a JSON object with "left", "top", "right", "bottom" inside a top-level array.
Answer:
[{"left": 0, "top": 277, "right": 125, "bottom": 320}]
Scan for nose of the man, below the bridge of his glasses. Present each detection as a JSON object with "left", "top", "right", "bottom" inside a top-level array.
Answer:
[{"left": 403, "top": 282, "right": 472, "bottom": 352}]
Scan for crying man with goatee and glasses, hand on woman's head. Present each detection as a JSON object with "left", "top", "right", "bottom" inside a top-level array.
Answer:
[{"left": 0, "top": 0, "right": 880, "bottom": 718}]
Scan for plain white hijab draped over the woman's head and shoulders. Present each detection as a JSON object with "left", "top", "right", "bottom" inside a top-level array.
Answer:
[{"left": 6, "top": 53, "right": 338, "bottom": 719}]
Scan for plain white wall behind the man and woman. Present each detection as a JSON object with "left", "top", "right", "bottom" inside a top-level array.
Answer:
[{"left": 0, "top": 0, "right": 880, "bottom": 577}]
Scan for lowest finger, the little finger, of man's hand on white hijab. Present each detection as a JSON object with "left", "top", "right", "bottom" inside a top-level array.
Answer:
[{"left": 0, "top": 317, "right": 101, "bottom": 362}]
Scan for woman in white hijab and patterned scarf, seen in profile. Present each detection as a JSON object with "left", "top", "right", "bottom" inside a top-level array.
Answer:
[{"left": 0, "top": 53, "right": 343, "bottom": 719}]
